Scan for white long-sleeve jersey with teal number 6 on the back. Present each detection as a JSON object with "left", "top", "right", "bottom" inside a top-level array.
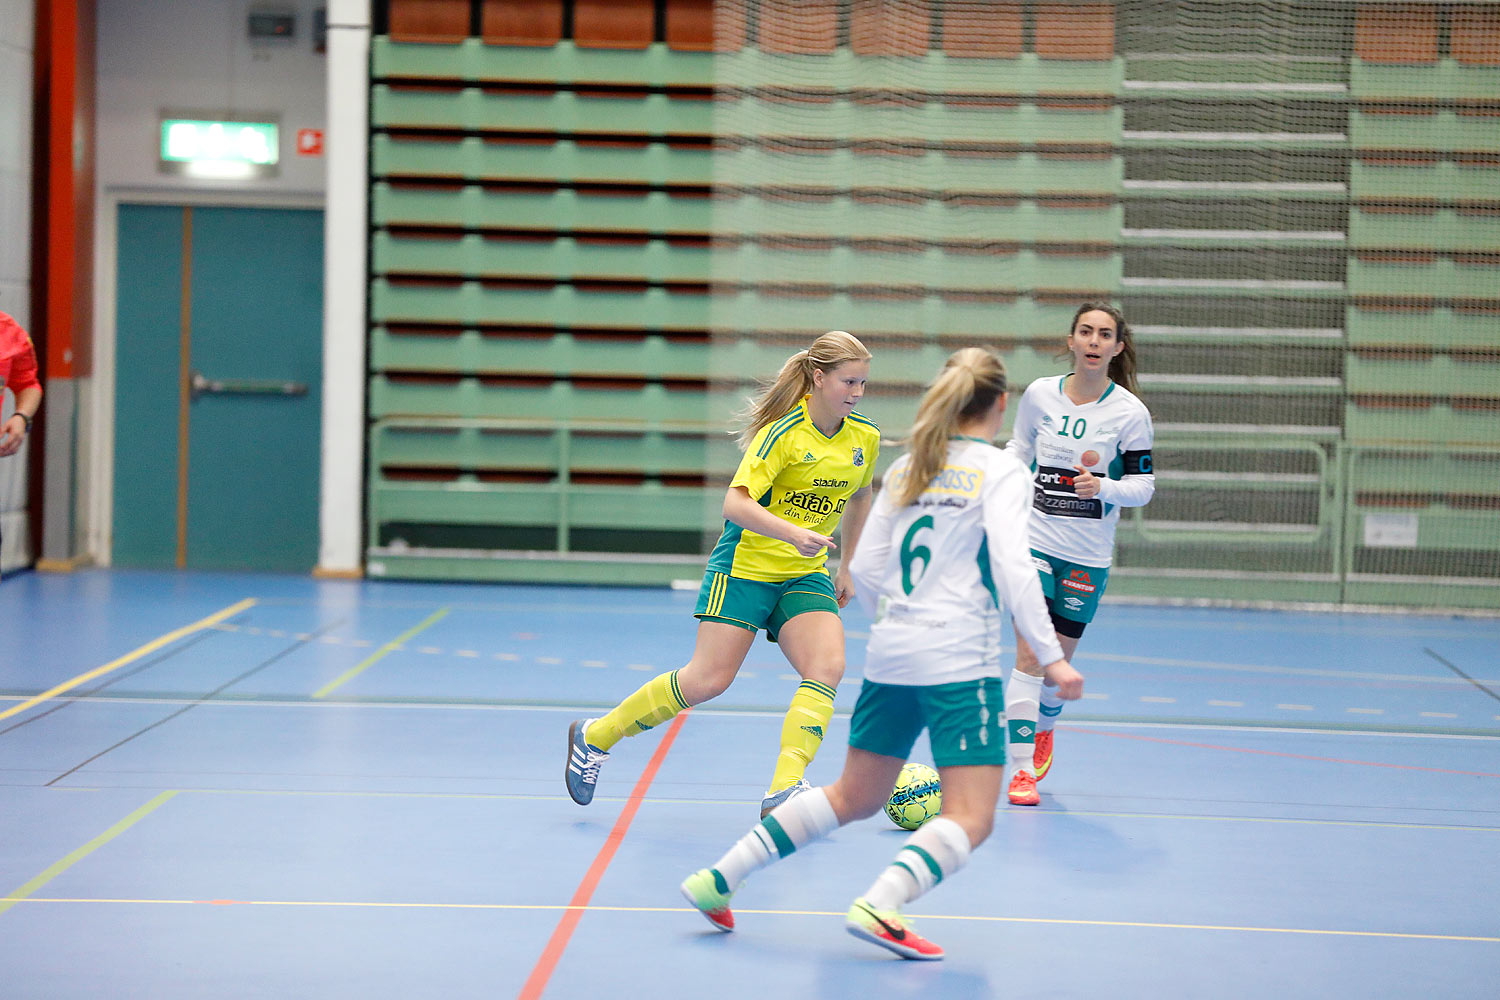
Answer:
[{"left": 849, "top": 438, "right": 1062, "bottom": 684}]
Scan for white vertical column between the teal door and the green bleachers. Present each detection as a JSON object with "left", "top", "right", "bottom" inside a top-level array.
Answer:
[{"left": 317, "top": 0, "right": 371, "bottom": 576}]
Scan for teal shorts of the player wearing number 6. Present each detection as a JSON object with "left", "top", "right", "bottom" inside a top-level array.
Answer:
[{"left": 849, "top": 678, "right": 1005, "bottom": 768}]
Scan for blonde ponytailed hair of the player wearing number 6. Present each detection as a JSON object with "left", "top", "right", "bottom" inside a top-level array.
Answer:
[{"left": 891, "top": 348, "right": 1007, "bottom": 507}]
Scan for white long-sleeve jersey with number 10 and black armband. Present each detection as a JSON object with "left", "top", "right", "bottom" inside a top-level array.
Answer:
[{"left": 1005, "top": 375, "right": 1157, "bottom": 568}]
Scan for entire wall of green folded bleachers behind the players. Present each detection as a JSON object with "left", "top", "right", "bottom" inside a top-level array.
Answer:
[{"left": 368, "top": 0, "right": 1500, "bottom": 606}]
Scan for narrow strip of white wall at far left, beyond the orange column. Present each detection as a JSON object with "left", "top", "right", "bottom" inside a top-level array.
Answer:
[{"left": 0, "top": 0, "right": 36, "bottom": 570}]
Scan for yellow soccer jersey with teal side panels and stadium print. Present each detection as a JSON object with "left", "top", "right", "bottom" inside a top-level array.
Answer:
[{"left": 708, "top": 396, "right": 881, "bottom": 583}]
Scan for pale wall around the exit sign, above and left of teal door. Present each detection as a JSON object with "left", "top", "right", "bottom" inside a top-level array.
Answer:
[{"left": 87, "top": 0, "right": 345, "bottom": 564}]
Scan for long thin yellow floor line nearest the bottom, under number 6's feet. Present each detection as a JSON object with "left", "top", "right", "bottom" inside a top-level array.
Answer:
[{"left": 5, "top": 897, "right": 1500, "bottom": 945}]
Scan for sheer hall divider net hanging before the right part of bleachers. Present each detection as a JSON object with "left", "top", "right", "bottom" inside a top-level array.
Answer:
[{"left": 711, "top": 0, "right": 1500, "bottom": 607}]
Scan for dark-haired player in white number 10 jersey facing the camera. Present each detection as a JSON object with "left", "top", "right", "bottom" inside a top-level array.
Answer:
[{"left": 1005, "top": 303, "right": 1157, "bottom": 805}]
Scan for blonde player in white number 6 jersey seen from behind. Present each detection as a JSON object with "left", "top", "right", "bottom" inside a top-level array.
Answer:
[{"left": 683, "top": 348, "right": 1083, "bottom": 960}]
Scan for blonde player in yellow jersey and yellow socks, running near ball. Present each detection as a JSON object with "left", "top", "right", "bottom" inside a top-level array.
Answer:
[{"left": 566, "top": 330, "right": 881, "bottom": 816}]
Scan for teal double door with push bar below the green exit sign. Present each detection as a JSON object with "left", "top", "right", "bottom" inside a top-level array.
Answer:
[{"left": 113, "top": 204, "right": 323, "bottom": 573}]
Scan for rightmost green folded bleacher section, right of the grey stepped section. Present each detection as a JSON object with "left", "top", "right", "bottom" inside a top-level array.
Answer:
[{"left": 1346, "top": 4, "right": 1500, "bottom": 601}]
